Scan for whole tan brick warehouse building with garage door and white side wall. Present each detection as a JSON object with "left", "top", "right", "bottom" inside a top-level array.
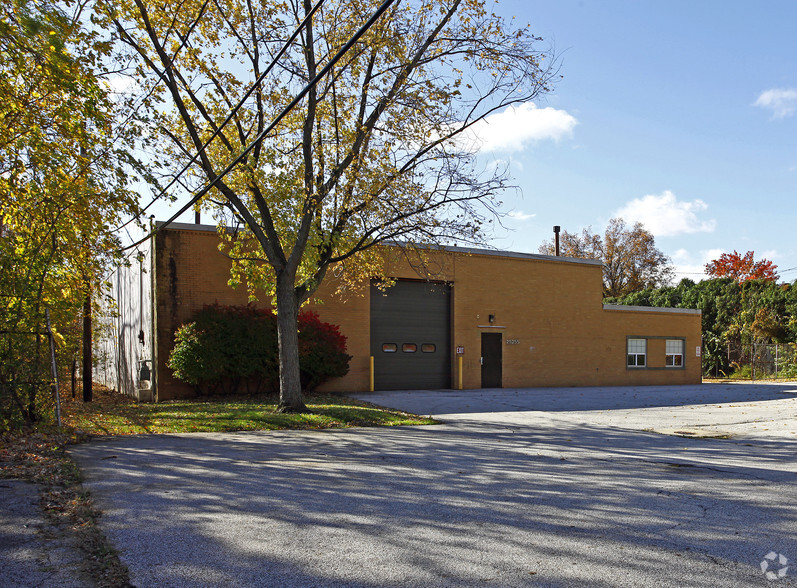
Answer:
[{"left": 96, "top": 224, "right": 701, "bottom": 401}]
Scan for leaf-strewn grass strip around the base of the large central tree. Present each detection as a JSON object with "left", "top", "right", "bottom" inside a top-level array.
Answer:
[{"left": 62, "top": 390, "right": 438, "bottom": 435}]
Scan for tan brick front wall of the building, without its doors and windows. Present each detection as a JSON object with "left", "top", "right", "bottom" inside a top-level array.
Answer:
[{"left": 156, "top": 229, "right": 701, "bottom": 400}]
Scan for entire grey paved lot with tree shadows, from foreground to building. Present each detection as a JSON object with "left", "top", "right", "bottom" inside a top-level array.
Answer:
[{"left": 73, "top": 385, "right": 797, "bottom": 588}]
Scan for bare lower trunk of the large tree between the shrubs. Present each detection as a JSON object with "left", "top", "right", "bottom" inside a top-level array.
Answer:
[{"left": 277, "top": 273, "right": 307, "bottom": 412}]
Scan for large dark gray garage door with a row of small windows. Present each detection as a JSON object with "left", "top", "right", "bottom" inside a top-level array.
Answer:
[{"left": 371, "top": 280, "right": 451, "bottom": 390}]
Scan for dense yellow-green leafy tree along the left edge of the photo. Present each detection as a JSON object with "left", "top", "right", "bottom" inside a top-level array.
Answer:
[{"left": 0, "top": 0, "right": 140, "bottom": 427}]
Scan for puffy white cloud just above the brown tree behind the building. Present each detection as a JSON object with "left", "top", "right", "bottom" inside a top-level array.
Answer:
[{"left": 615, "top": 190, "right": 717, "bottom": 237}]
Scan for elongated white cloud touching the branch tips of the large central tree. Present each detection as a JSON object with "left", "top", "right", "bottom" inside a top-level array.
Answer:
[{"left": 460, "top": 102, "right": 578, "bottom": 153}]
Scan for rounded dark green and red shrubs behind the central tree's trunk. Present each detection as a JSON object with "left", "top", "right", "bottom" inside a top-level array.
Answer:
[{"left": 168, "top": 304, "right": 351, "bottom": 394}]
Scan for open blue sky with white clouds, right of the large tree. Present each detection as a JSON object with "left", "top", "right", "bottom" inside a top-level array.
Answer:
[{"left": 482, "top": 0, "right": 797, "bottom": 282}]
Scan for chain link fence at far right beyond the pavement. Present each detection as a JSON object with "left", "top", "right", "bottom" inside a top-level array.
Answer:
[{"left": 710, "top": 343, "right": 797, "bottom": 380}]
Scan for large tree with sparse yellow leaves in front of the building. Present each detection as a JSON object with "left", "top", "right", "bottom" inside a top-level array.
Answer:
[{"left": 108, "top": 0, "right": 556, "bottom": 411}]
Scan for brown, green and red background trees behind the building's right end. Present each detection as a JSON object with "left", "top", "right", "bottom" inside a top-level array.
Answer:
[{"left": 539, "top": 222, "right": 797, "bottom": 377}]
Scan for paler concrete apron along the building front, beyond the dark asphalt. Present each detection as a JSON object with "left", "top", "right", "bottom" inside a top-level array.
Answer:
[{"left": 355, "top": 382, "right": 797, "bottom": 442}]
